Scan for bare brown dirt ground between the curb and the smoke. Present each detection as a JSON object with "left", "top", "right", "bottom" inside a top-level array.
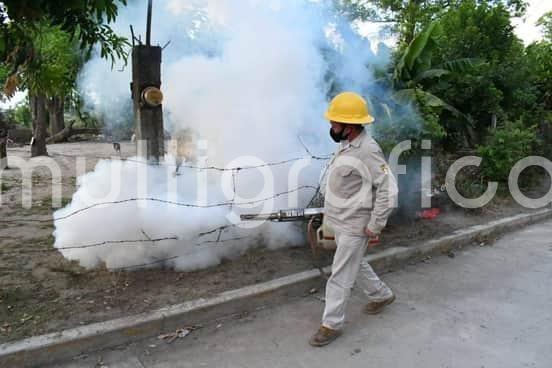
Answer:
[{"left": 0, "top": 142, "right": 548, "bottom": 343}]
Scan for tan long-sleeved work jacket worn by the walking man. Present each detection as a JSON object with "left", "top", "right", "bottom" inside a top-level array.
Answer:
[{"left": 323, "top": 130, "right": 398, "bottom": 235}]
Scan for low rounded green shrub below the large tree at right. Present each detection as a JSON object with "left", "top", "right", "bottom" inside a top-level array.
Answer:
[{"left": 477, "top": 121, "right": 537, "bottom": 182}]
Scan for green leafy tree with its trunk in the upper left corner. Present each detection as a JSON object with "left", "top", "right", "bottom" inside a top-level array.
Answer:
[{"left": 0, "top": 0, "right": 128, "bottom": 156}]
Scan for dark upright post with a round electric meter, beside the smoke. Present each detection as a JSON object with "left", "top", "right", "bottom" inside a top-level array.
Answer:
[{"left": 131, "top": 0, "right": 165, "bottom": 162}]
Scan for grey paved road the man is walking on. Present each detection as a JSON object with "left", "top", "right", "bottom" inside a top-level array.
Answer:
[{"left": 56, "top": 221, "right": 552, "bottom": 368}]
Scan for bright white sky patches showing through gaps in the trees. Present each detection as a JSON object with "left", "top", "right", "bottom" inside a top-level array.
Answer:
[{"left": 0, "top": 0, "right": 552, "bottom": 109}]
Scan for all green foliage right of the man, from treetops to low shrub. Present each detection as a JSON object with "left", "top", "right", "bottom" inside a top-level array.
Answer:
[{"left": 337, "top": 0, "right": 552, "bottom": 197}]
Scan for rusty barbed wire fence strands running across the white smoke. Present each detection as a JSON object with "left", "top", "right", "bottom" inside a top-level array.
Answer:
[{"left": 0, "top": 147, "right": 331, "bottom": 271}]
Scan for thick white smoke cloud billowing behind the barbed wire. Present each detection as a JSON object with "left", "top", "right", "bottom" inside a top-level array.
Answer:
[{"left": 54, "top": 0, "right": 386, "bottom": 270}]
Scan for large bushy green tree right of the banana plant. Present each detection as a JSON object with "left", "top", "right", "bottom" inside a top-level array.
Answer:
[{"left": 429, "top": 0, "right": 536, "bottom": 148}]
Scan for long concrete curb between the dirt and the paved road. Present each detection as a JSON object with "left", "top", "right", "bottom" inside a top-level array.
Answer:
[{"left": 0, "top": 209, "right": 552, "bottom": 367}]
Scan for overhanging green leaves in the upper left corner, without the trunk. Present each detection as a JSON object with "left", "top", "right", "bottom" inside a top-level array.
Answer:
[{"left": 0, "top": 0, "right": 129, "bottom": 97}]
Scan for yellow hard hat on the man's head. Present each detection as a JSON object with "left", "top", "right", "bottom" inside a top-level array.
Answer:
[{"left": 325, "top": 92, "right": 374, "bottom": 124}]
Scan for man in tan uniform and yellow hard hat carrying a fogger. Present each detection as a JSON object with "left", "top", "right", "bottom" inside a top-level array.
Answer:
[{"left": 309, "top": 92, "right": 398, "bottom": 346}]
